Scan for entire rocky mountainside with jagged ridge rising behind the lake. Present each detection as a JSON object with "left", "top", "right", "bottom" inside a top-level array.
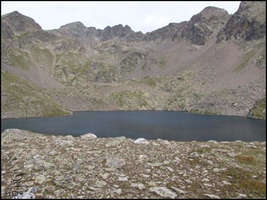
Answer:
[{"left": 1, "top": 2, "right": 266, "bottom": 118}]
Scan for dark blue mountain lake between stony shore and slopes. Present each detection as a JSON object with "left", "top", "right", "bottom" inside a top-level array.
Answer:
[{"left": 1, "top": 111, "right": 266, "bottom": 141}]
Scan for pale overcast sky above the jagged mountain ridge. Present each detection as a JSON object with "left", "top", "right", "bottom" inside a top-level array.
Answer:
[{"left": 1, "top": 1, "right": 240, "bottom": 33}]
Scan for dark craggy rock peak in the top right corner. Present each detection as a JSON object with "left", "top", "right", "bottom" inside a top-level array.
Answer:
[{"left": 217, "top": 1, "right": 266, "bottom": 42}]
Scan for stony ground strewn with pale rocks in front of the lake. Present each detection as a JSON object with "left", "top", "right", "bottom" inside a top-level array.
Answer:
[{"left": 1, "top": 129, "right": 266, "bottom": 198}]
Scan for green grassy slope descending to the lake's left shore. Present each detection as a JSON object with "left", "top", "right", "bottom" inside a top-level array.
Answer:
[{"left": 1, "top": 71, "right": 71, "bottom": 117}]
